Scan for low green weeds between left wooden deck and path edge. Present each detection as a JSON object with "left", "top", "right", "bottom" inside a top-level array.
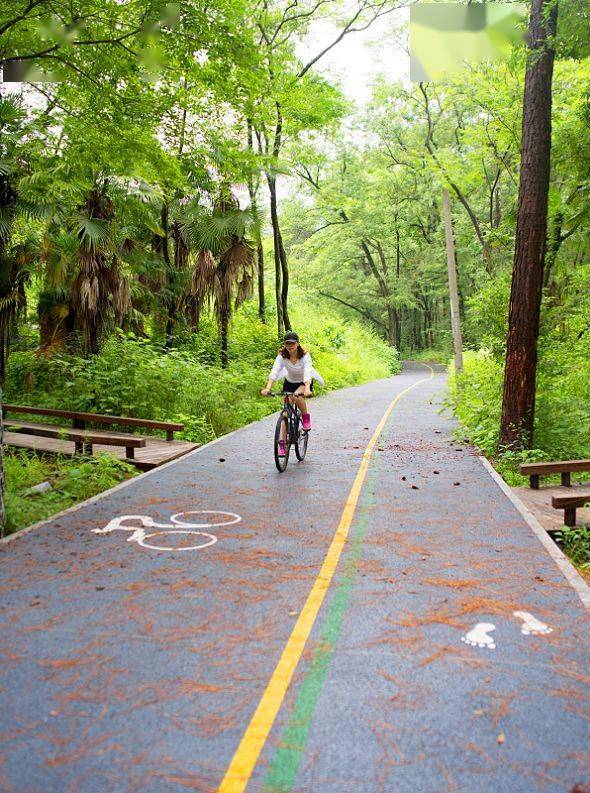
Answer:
[{"left": 4, "top": 449, "right": 137, "bottom": 534}]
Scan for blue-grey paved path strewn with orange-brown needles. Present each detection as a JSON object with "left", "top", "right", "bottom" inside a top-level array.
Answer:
[{"left": 0, "top": 365, "right": 590, "bottom": 793}]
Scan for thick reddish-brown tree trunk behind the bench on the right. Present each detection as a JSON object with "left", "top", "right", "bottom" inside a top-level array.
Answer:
[{"left": 500, "top": 0, "right": 557, "bottom": 449}]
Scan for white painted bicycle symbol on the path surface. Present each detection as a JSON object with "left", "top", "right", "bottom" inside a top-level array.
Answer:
[{"left": 92, "top": 509, "right": 242, "bottom": 551}]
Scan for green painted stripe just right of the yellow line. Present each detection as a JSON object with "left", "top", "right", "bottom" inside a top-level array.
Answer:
[{"left": 262, "top": 422, "right": 389, "bottom": 793}]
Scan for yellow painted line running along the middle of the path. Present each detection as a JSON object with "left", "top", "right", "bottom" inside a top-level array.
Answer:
[{"left": 218, "top": 364, "right": 434, "bottom": 793}]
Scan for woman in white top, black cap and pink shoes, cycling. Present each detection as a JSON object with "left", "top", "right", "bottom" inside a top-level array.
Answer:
[{"left": 260, "top": 330, "right": 324, "bottom": 457}]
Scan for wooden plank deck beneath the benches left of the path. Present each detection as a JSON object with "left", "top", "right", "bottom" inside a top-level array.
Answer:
[{"left": 4, "top": 431, "right": 200, "bottom": 471}]
